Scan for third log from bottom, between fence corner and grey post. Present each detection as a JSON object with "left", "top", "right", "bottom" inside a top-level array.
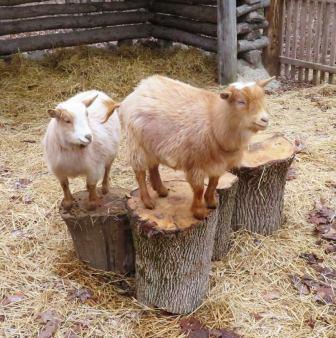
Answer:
[{"left": 151, "top": 2, "right": 217, "bottom": 24}]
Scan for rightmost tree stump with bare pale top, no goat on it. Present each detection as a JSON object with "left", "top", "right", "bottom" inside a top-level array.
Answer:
[{"left": 231, "top": 134, "right": 295, "bottom": 235}]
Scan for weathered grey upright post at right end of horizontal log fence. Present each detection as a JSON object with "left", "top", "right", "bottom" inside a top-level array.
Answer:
[{"left": 217, "top": 0, "right": 237, "bottom": 84}]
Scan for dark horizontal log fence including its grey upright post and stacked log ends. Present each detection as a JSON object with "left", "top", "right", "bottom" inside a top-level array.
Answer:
[{"left": 0, "top": 0, "right": 270, "bottom": 83}]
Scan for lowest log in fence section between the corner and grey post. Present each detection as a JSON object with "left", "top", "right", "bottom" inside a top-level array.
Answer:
[{"left": 152, "top": 26, "right": 217, "bottom": 53}]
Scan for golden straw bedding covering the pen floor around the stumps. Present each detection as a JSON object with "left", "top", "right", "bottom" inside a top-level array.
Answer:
[{"left": 0, "top": 48, "right": 336, "bottom": 338}]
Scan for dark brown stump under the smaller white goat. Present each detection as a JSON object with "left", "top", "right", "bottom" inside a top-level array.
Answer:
[{"left": 59, "top": 187, "right": 134, "bottom": 273}]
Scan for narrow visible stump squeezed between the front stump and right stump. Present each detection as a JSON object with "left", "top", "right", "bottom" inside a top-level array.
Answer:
[{"left": 212, "top": 173, "right": 238, "bottom": 261}]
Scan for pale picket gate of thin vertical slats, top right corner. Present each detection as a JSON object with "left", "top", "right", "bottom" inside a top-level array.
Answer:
[{"left": 280, "top": 0, "right": 336, "bottom": 84}]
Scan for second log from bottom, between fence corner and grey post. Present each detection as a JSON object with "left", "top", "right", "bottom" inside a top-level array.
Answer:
[{"left": 150, "top": 14, "right": 217, "bottom": 37}]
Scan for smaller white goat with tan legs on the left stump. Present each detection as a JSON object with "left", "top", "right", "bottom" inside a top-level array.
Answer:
[{"left": 43, "top": 90, "right": 120, "bottom": 210}]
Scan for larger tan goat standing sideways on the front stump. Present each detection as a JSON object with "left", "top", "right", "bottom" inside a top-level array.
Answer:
[{"left": 106, "top": 75, "right": 272, "bottom": 219}]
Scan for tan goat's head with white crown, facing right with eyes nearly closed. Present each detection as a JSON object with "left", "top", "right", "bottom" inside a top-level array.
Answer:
[{"left": 221, "top": 78, "right": 273, "bottom": 132}]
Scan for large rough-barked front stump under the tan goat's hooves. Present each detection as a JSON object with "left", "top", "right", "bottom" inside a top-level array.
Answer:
[{"left": 127, "top": 181, "right": 217, "bottom": 314}]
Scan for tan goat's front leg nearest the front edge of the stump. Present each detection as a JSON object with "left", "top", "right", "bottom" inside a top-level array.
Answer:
[{"left": 186, "top": 172, "right": 208, "bottom": 219}]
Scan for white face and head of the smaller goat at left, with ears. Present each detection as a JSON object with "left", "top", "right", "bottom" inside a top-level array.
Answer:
[{"left": 48, "top": 96, "right": 96, "bottom": 147}]
